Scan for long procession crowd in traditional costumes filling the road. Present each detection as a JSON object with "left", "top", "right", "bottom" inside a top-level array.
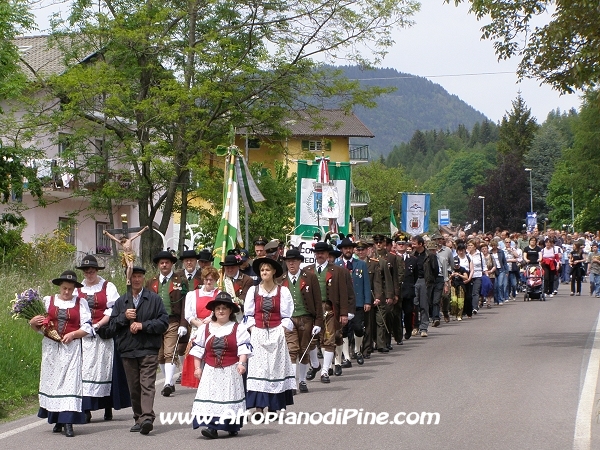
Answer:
[{"left": 30, "top": 230, "right": 600, "bottom": 439}]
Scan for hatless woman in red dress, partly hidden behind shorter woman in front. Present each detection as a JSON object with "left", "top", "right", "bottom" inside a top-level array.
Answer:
[{"left": 181, "top": 266, "right": 221, "bottom": 389}]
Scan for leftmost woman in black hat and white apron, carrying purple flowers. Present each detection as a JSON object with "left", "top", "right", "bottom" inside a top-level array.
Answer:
[{"left": 29, "top": 270, "right": 94, "bottom": 437}]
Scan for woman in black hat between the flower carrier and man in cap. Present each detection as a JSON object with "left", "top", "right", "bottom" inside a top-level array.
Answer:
[{"left": 77, "top": 255, "right": 131, "bottom": 422}]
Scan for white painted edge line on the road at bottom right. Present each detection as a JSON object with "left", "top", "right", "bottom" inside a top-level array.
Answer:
[{"left": 573, "top": 314, "right": 600, "bottom": 450}]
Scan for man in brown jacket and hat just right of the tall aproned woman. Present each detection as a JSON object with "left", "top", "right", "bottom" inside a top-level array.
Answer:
[{"left": 281, "top": 248, "right": 323, "bottom": 392}]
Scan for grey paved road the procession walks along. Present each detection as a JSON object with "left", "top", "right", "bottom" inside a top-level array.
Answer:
[{"left": 0, "top": 284, "right": 600, "bottom": 450}]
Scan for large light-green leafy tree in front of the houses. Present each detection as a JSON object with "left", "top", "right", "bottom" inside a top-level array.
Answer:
[{"left": 23, "top": 0, "right": 418, "bottom": 258}]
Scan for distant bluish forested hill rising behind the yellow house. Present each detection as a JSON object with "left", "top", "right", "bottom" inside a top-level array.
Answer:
[{"left": 338, "top": 66, "right": 486, "bottom": 157}]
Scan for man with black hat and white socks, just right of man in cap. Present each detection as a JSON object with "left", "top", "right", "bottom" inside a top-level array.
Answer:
[{"left": 146, "top": 250, "right": 189, "bottom": 397}]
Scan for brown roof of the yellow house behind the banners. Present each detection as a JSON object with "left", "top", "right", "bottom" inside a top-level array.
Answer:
[{"left": 237, "top": 109, "right": 375, "bottom": 138}]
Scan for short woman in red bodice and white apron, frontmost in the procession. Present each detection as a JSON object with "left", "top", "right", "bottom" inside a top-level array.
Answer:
[{"left": 190, "top": 292, "right": 250, "bottom": 439}]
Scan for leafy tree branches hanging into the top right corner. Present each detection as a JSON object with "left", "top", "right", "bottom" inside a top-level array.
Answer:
[{"left": 445, "top": 0, "right": 600, "bottom": 93}]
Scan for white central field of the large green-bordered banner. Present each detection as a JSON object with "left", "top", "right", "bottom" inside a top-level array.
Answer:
[{"left": 299, "top": 178, "right": 347, "bottom": 227}]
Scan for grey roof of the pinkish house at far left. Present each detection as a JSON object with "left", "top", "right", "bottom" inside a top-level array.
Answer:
[{"left": 13, "top": 36, "right": 66, "bottom": 79}]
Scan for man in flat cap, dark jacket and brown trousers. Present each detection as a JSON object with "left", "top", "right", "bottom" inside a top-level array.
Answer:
[{"left": 108, "top": 267, "right": 169, "bottom": 434}]
